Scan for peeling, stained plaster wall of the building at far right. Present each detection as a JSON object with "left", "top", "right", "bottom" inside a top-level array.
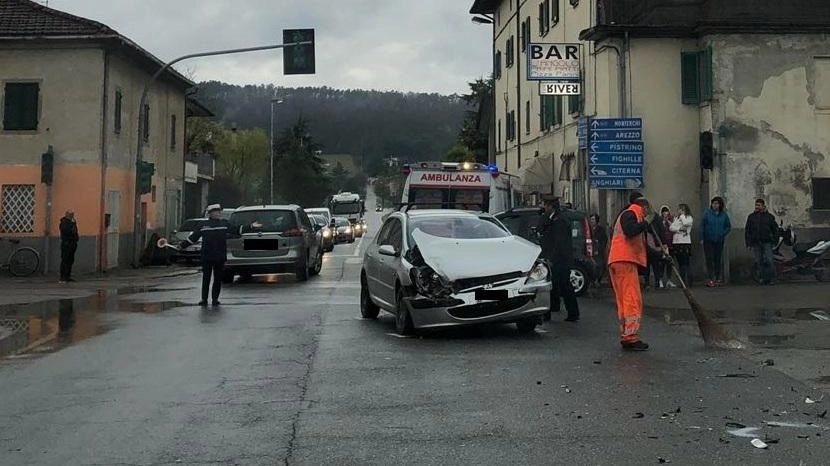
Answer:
[{"left": 706, "top": 34, "right": 830, "bottom": 236}]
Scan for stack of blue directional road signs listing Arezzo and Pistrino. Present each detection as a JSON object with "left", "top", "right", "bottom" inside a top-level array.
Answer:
[{"left": 587, "top": 118, "right": 645, "bottom": 189}]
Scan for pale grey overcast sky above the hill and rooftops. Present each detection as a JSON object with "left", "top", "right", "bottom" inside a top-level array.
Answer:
[{"left": 49, "top": 0, "right": 492, "bottom": 93}]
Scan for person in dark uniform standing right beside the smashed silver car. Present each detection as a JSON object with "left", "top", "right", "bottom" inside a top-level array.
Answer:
[{"left": 537, "top": 198, "right": 579, "bottom": 322}]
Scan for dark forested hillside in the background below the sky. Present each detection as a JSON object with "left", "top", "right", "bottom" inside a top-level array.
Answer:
[{"left": 197, "top": 81, "right": 468, "bottom": 175}]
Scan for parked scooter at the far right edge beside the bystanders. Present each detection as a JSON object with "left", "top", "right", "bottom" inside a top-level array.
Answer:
[{"left": 773, "top": 224, "right": 830, "bottom": 281}]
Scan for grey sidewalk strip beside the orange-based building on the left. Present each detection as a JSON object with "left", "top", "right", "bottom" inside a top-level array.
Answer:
[{"left": 0, "top": 265, "right": 199, "bottom": 306}]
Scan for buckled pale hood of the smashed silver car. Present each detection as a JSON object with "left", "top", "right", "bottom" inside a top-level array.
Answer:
[{"left": 412, "top": 229, "right": 542, "bottom": 281}]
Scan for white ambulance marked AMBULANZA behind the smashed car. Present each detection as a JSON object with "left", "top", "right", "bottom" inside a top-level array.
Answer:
[{"left": 401, "top": 162, "right": 520, "bottom": 214}]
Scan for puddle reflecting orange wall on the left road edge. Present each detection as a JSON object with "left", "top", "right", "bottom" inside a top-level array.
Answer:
[{"left": 0, "top": 287, "right": 188, "bottom": 358}]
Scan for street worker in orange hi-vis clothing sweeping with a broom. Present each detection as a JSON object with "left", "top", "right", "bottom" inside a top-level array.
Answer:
[{"left": 608, "top": 192, "right": 655, "bottom": 351}]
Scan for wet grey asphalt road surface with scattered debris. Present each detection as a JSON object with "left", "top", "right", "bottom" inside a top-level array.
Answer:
[{"left": 0, "top": 202, "right": 830, "bottom": 466}]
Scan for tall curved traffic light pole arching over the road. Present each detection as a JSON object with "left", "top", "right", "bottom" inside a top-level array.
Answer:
[{"left": 133, "top": 41, "right": 314, "bottom": 267}]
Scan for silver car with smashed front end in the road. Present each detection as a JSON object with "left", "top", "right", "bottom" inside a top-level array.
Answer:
[{"left": 360, "top": 210, "right": 551, "bottom": 334}]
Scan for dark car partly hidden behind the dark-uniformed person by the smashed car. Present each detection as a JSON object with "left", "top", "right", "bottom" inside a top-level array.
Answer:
[{"left": 496, "top": 207, "right": 597, "bottom": 296}]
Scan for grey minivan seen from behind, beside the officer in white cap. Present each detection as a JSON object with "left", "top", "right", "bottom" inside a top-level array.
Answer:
[{"left": 224, "top": 205, "right": 323, "bottom": 283}]
